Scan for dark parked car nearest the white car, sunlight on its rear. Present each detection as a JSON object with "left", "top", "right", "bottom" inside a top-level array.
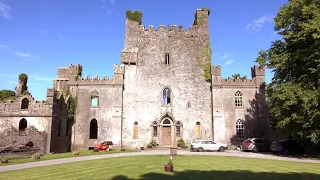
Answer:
[{"left": 241, "top": 138, "right": 271, "bottom": 152}]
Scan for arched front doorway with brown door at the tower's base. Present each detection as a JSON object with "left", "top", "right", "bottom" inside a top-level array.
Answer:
[{"left": 160, "top": 117, "right": 174, "bottom": 146}]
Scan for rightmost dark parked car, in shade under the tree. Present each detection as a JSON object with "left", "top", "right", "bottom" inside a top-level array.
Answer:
[{"left": 270, "top": 139, "right": 306, "bottom": 154}]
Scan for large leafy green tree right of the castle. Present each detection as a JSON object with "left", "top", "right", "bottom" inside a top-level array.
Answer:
[{"left": 256, "top": 0, "right": 320, "bottom": 144}]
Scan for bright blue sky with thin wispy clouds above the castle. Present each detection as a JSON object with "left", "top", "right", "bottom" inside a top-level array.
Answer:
[{"left": 0, "top": 0, "right": 287, "bottom": 100}]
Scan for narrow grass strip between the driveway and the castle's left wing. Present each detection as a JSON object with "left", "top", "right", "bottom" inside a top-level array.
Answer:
[{"left": 0, "top": 150, "right": 137, "bottom": 166}]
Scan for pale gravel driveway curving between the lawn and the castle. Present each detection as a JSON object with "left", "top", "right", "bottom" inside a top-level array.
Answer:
[{"left": 0, "top": 150, "right": 320, "bottom": 172}]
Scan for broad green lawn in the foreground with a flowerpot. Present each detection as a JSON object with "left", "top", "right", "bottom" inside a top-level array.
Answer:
[{"left": 0, "top": 155, "right": 320, "bottom": 180}]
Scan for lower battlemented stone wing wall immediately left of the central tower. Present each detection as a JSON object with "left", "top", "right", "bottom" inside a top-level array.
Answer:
[{"left": 69, "top": 66, "right": 124, "bottom": 150}]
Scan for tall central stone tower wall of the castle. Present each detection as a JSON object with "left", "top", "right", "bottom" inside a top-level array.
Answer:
[{"left": 121, "top": 11, "right": 212, "bottom": 148}]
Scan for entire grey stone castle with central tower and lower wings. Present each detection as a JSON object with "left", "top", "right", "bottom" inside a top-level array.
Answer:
[{"left": 0, "top": 9, "right": 269, "bottom": 152}]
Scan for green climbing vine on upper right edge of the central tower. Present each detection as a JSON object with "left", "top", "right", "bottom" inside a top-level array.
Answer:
[{"left": 197, "top": 44, "right": 212, "bottom": 81}]
